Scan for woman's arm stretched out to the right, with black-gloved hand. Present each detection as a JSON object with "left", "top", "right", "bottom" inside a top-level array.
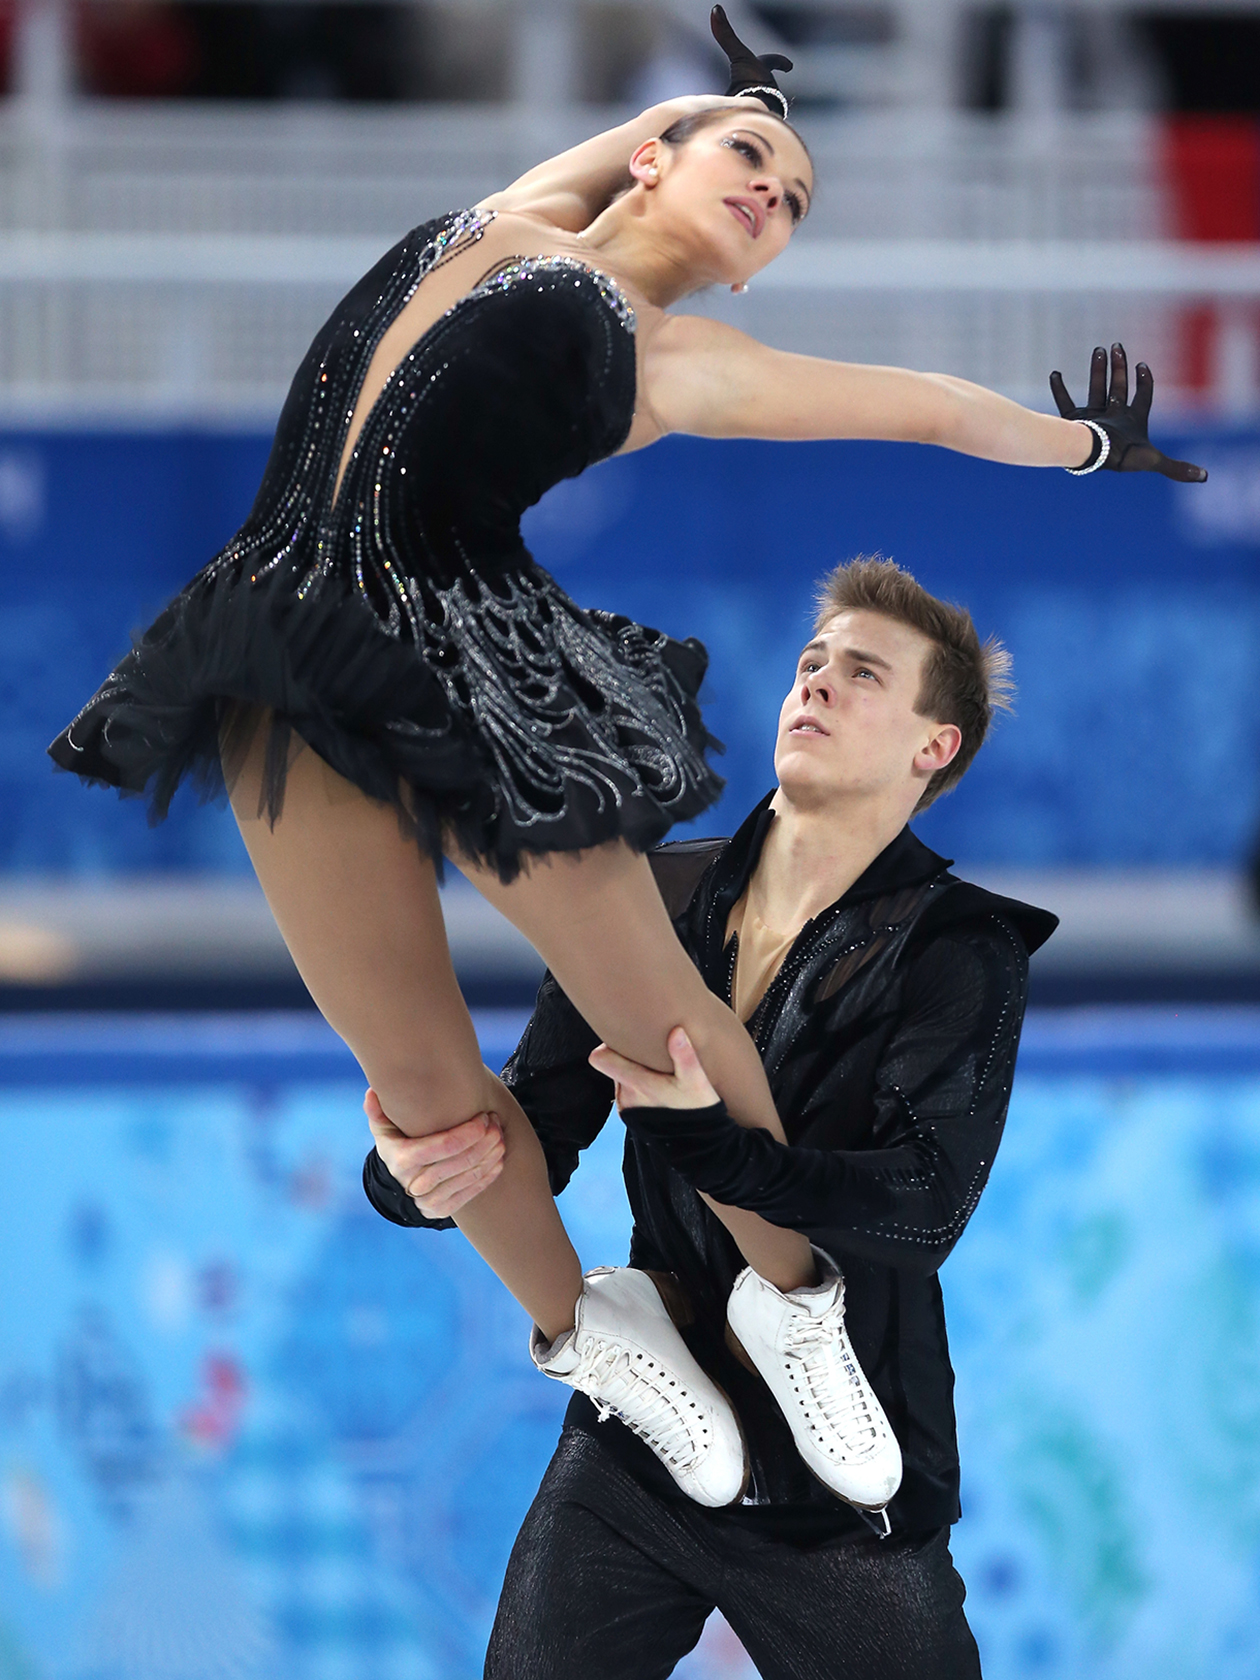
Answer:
[{"left": 643, "top": 316, "right": 1206, "bottom": 482}]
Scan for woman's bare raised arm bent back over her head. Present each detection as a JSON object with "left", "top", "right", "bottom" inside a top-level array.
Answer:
[{"left": 480, "top": 94, "right": 746, "bottom": 234}]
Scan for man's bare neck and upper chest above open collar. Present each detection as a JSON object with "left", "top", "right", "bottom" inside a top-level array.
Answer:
[{"left": 749, "top": 788, "right": 906, "bottom": 934}]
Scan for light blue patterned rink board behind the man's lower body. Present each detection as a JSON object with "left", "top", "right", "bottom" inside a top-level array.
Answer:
[{"left": 0, "top": 1010, "right": 1260, "bottom": 1680}]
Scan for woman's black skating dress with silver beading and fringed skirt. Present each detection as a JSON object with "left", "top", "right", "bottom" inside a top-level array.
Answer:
[{"left": 50, "top": 210, "right": 721, "bottom": 880}]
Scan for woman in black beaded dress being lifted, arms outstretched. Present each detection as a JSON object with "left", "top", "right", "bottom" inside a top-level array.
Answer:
[{"left": 50, "top": 8, "right": 1201, "bottom": 1504}]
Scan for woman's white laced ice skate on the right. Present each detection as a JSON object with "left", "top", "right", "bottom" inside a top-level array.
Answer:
[{"left": 726, "top": 1248, "right": 900, "bottom": 1524}]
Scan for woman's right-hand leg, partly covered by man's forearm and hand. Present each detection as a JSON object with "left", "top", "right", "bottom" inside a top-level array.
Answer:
[{"left": 459, "top": 842, "right": 816, "bottom": 1289}]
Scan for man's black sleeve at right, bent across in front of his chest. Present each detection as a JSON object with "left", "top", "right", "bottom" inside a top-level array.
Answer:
[{"left": 623, "top": 917, "right": 1028, "bottom": 1272}]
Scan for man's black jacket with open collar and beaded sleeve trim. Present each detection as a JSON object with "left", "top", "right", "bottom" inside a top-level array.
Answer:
[{"left": 365, "top": 801, "right": 1055, "bottom": 1544}]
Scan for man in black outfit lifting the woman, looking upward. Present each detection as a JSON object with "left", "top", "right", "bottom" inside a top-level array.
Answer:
[{"left": 365, "top": 559, "right": 1055, "bottom": 1680}]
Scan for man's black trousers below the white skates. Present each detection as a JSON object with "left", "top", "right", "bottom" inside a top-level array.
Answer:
[{"left": 486, "top": 1430, "right": 979, "bottom": 1680}]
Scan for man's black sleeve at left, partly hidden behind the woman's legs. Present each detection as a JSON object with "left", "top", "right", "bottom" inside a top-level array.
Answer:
[{"left": 363, "top": 974, "right": 613, "bottom": 1231}]
